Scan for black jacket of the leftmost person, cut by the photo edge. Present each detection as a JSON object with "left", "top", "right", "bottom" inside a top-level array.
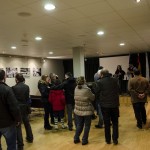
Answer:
[{"left": 0, "top": 82, "right": 21, "bottom": 128}]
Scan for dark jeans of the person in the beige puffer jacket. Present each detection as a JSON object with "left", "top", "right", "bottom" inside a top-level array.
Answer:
[{"left": 74, "top": 115, "right": 92, "bottom": 143}]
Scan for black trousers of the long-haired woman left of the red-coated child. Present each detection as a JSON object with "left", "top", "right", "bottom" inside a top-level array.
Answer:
[{"left": 43, "top": 102, "right": 54, "bottom": 128}]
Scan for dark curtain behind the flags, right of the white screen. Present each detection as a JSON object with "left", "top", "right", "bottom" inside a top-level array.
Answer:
[{"left": 129, "top": 53, "right": 146, "bottom": 77}]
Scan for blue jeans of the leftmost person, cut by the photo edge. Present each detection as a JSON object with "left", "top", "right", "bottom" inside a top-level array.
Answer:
[{"left": 0, "top": 125, "right": 17, "bottom": 150}]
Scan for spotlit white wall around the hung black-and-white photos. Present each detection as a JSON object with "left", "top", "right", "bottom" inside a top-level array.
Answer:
[{"left": 0, "top": 57, "right": 64, "bottom": 95}]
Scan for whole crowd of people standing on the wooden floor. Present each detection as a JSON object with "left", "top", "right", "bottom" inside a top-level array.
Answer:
[{"left": 0, "top": 65, "right": 149, "bottom": 150}]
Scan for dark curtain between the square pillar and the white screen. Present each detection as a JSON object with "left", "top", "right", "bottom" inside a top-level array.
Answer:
[{"left": 85, "top": 57, "right": 99, "bottom": 82}]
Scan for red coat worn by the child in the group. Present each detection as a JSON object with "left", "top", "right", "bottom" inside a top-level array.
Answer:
[{"left": 49, "top": 90, "right": 65, "bottom": 111}]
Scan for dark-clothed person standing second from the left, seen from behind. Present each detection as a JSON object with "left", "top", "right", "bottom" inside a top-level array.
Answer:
[{"left": 12, "top": 73, "right": 33, "bottom": 150}]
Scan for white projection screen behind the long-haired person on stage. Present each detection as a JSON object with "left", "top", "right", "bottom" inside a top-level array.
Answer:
[{"left": 99, "top": 56, "right": 129, "bottom": 78}]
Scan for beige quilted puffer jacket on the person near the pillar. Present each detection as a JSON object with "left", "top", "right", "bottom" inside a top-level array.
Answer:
[{"left": 74, "top": 85, "right": 95, "bottom": 116}]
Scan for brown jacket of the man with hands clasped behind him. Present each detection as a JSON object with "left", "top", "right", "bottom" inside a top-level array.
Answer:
[{"left": 128, "top": 76, "right": 149, "bottom": 103}]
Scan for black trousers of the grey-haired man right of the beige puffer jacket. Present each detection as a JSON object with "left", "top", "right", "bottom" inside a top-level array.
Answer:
[{"left": 101, "top": 107, "right": 119, "bottom": 142}]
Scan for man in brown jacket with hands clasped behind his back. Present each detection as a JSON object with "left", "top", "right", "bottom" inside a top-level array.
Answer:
[{"left": 128, "top": 70, "right": 149, "bottom": 129}]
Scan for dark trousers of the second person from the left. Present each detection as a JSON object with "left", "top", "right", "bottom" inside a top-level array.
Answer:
[{"left": 17, "top": 106, "right": 33, "bottom": 148}]
